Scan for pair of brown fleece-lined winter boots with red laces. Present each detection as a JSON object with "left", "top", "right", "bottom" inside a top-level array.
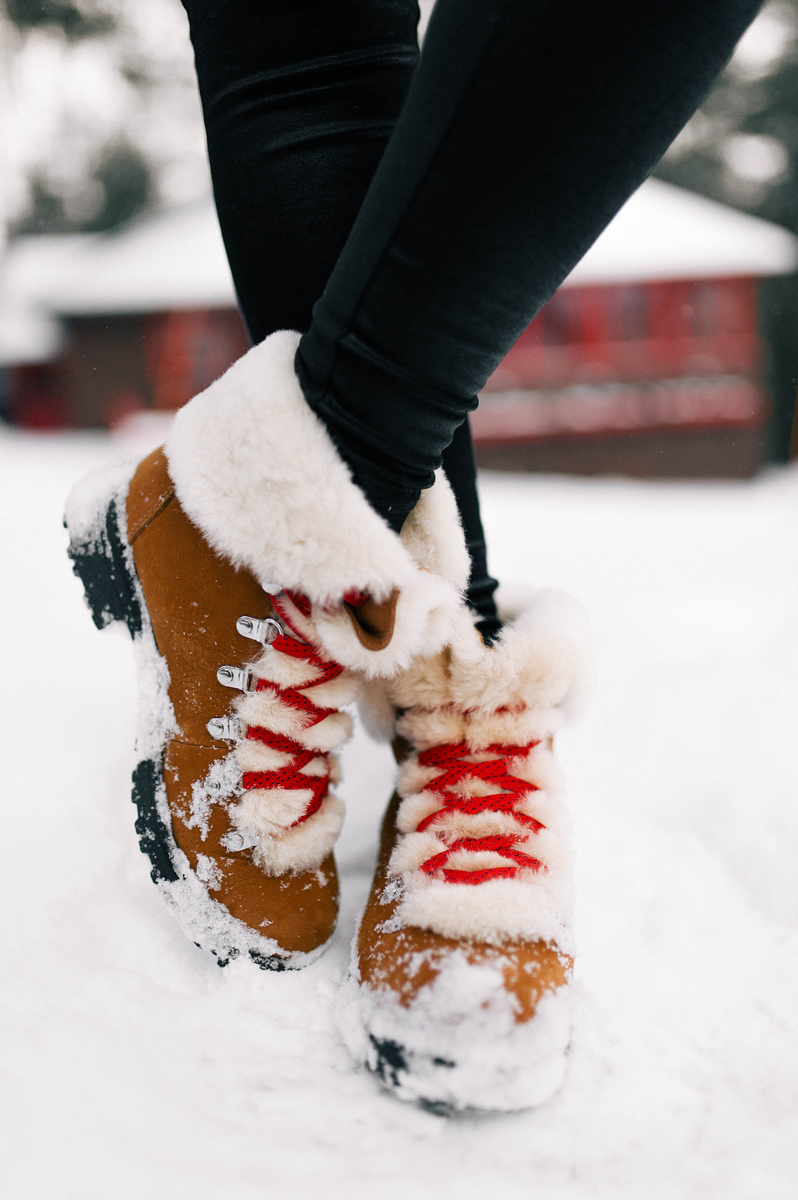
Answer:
[{"left": 67, "top": 332, "right": 583, "bottom": 1110}]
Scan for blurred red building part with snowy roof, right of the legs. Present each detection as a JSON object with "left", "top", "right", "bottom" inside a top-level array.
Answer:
[{"left": 472, "top": 180, "right": 798, "bottom": 476}]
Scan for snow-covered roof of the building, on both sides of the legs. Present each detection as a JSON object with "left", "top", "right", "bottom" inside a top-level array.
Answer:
[{"left": 0, "top": 179, "right": 798, "bottom": 364}]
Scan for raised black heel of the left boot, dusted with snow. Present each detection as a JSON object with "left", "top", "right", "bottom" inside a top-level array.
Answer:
[{"left": 64, "top": 472, "right": 142, "bottom": 637}]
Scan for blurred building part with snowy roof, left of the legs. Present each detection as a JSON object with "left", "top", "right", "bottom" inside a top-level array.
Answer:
[{"left": 0, "top": 202, "right": 248, "bottom": 428}]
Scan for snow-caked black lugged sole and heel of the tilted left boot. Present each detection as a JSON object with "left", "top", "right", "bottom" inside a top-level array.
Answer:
[{"left": 64, "top": 468, "right": 325, "bottom": 971}]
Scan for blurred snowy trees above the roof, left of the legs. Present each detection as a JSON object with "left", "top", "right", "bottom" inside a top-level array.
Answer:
[{"left": 0, "top": 0, "right": 210, "bottom": 245}]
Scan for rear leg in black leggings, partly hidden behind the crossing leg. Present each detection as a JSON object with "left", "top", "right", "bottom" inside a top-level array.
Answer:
[{"left": 184, "top": 0, "right": 498, "bottom": 631}]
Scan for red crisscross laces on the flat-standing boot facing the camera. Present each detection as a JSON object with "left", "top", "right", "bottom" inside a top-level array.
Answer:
[{"left": 418, "top": 740, "right": 545, "bottom": 883}]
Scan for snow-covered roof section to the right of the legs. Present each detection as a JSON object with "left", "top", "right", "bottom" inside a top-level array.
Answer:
[{"left": 563, "top": 179, "right": 798, "bottom": 287}]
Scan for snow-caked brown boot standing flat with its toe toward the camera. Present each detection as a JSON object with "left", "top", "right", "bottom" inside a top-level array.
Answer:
[{"left": 338, "top": 592, "right": 587, "bottom": 1112}]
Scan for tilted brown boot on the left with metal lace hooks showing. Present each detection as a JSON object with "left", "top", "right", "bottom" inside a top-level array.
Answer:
[{"left": 66, "top": 334, "right": 468, "bottom": 970}]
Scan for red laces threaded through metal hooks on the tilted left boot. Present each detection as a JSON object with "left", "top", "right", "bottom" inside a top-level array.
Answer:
[{"left": 241, "top": 592, "right": 344, "bottom": 829}]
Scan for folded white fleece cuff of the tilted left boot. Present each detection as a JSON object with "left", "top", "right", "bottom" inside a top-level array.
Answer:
[{"left": 166, "top": 330, "right": 468, "bottom": 677}]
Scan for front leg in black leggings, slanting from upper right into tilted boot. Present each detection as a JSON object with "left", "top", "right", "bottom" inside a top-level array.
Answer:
[{"left": 296, "top": 0, "right": 761, "bottom": 529}]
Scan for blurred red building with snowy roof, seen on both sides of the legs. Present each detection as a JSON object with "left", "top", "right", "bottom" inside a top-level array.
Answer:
[{"left": 0, "top": 180, "right": 798, "bottom": 476}]
